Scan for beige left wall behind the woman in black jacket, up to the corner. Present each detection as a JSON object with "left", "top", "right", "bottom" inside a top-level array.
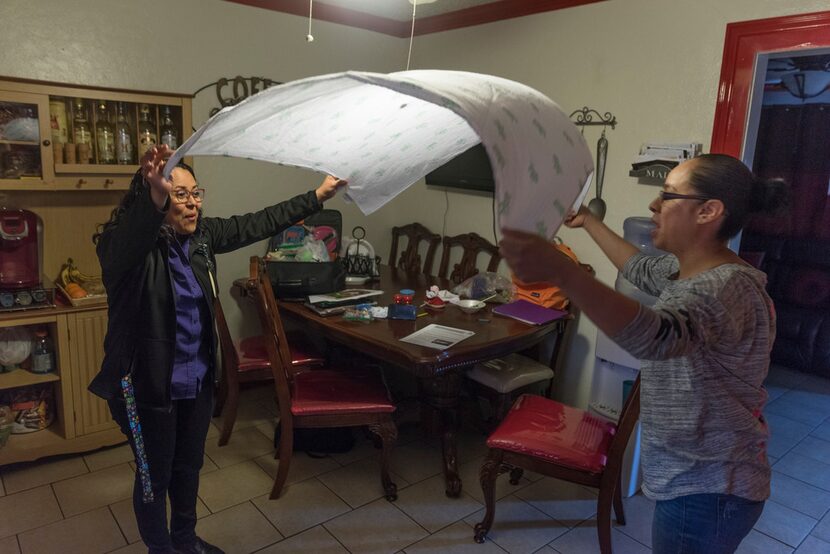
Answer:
[{"left": 0, "top": 0, "right": 407, "bottom": 336}]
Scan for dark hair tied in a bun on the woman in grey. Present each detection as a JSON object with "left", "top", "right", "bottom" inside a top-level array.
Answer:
[{"left": 689, "top": 154, "right": 790, "bottom": 240}]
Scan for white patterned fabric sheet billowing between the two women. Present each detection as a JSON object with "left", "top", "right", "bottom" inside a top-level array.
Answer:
[{"left": 167, "top": 70, "right": 594, "bottom": 238}]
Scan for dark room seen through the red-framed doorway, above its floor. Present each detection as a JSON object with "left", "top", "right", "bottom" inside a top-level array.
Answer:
[{"left": 740, "top": 48, "right": 830, "bottom": 378}]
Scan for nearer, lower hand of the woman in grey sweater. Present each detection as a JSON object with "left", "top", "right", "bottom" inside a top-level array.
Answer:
[{"left": 499, "top": 229, "right": 577, "bottom": 284}]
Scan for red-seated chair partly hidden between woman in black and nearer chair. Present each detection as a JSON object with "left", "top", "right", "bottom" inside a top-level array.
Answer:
[{"left": 213, "top": 297, "right": 326, "bottom": 446}]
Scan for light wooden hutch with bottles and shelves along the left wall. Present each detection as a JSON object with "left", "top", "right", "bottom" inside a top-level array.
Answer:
[{"left": 0, "top": 77, "right": 192, "bottom": 466}]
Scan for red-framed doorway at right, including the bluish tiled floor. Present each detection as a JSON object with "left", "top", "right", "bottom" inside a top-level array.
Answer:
[{"left": 711, "top": 12, "right": 830, "bottom": 552}]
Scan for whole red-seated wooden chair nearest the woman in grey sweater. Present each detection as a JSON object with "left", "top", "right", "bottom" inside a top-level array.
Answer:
[{"left": 475, "top": 376, "right": 640, "bottom": 554}]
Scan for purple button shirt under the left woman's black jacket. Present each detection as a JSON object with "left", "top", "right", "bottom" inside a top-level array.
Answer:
[{"left": 170, "top": 237, "right": 208, "bottom": 400}]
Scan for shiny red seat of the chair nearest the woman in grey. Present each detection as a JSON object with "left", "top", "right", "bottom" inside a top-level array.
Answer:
[{"left": 487, "top": 394, "right": 617, "bottom": 473}]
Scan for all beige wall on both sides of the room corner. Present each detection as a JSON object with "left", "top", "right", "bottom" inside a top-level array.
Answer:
[{"left": 0, "top": 0, "right": 827, "bottom": 403}]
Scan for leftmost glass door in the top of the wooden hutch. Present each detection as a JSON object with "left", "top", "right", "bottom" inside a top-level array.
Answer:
[{"left": 0, "top": 92, "right": 54, "bottom": 188}]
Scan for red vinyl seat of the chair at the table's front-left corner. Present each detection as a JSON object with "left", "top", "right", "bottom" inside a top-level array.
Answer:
[{"left": 291, "top": 368, "right": 395, "bottom": 416}]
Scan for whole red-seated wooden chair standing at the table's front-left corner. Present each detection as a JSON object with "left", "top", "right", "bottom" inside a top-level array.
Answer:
[{"left": 248, "top": 256, "right": 398, "bottom": 501}]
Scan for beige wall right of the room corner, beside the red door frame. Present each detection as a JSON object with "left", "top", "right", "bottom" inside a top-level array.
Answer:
[{"left": 360, "top": 0, "right": 828, "bottom": 405}]
